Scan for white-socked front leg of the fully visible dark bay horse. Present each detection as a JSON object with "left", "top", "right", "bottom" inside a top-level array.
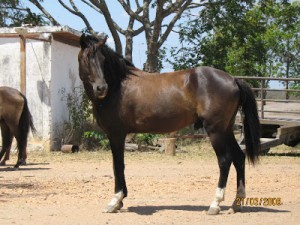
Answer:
[{"left": 105, "top": 135, "right": 127, "bottom": 213}]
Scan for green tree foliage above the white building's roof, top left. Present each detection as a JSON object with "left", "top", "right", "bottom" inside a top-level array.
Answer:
[{"left": 0, "top": 0, "right": 46, "bottom": 27}]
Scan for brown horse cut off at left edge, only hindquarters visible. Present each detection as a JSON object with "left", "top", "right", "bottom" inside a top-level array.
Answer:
[{"left": 0, "top": 87, "right": 35, "bottom": 168}]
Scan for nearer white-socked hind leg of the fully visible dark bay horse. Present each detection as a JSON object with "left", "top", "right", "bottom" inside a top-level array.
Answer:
[{"left": 208, "top": 133, "right": 233, "bottom": 215}]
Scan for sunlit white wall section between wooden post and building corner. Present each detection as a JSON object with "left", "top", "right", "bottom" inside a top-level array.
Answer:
[{"left": 26, "top": 39, "right": 51, "bottom": 142}]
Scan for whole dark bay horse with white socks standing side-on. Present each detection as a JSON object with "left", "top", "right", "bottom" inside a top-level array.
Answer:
[{"left": 78, "top": 35, "right": 260, "bottom": 214}]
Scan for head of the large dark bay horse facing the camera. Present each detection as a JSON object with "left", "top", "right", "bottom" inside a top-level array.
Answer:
[{"left": 78, "top": 34, "right": 108, "bottom": 99}]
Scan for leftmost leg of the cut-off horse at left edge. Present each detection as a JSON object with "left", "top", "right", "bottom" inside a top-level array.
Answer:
[{"left": 0, "top": 123, "right": 13, "bottom": 165}]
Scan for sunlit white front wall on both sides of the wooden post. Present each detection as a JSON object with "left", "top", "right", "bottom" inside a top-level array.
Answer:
[{"left": 0, "top": 38, "right": 51, "bottom": 146}]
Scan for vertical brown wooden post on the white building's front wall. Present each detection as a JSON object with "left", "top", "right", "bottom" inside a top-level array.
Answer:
[{"left": 20, "top": 35, "right": 26, "bottom": 96}]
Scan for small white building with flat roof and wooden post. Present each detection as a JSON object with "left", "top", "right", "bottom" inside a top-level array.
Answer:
[{"left": 0, "top": 26, "right": 81, "bottom": 150}]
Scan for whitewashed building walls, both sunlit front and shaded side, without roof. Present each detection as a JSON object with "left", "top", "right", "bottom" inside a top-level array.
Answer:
[{"left": 0, "top": 35, "right": 81, "bottom": 150}]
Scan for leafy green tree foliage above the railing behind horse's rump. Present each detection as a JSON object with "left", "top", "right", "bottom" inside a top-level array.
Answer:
[{"left": 167, "top": 0, "right": 300, "bottom": 88}]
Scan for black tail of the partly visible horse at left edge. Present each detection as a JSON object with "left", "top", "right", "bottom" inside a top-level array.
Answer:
[{"left": 19, "top": 94, "right": 36, "bottom": 143}]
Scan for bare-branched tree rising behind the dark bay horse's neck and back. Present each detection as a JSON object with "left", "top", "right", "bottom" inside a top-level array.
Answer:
[{"left": 29, "top": 0, "right": 205, "bottom": 72}]
